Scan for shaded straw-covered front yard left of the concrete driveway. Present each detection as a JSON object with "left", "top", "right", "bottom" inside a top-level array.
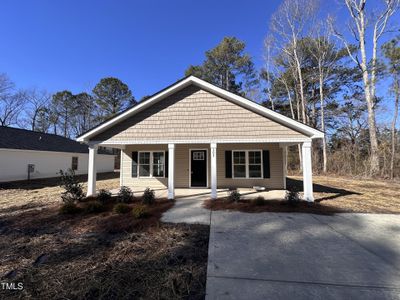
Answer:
[{"left": 0, "top": 199, "right": 209, "bottom": 299}]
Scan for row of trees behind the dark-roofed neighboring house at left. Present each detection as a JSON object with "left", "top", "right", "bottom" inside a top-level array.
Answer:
[{"left": 0, "top": 74, "right": 136, "bottom": 138}]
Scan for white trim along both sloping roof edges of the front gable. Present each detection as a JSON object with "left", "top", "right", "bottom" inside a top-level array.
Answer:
[{"left": 77, "top": 75, "right": 324, "bottom": 142}]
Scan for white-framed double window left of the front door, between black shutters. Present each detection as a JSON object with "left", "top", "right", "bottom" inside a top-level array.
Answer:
[{"left": 139, "top": 151, "right": 165, "bottom": 177}]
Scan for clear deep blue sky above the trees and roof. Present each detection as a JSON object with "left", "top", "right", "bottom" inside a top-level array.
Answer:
[{"left": 0, "top": 0, "right": 399, "bottom": 126}]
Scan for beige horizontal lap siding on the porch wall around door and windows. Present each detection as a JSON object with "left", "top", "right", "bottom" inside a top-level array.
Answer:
[{"left": 121, "top": 143, "right": 286, "bottom": 191}]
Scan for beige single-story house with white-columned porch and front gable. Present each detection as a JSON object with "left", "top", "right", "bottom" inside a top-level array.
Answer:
[{"left": 77, "top": 76, "right": 324, "bottom": 201}]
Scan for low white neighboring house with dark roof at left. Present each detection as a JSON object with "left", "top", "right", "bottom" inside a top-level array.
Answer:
[{"left": 0, "top": 126, "right": 114, "bottom": 182}]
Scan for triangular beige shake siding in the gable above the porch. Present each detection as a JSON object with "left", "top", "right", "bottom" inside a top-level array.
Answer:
[{"left": 91, "top": 85, "right": 305, "bottom": 143}]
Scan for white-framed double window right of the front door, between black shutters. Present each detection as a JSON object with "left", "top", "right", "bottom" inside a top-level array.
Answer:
[{"left": 232, "top": 150, "right": 262, "bottom": 178}]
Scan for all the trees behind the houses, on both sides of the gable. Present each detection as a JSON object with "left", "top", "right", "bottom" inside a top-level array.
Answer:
[{"left": 0, "top": 0, "right": 400, "bottom": 178}]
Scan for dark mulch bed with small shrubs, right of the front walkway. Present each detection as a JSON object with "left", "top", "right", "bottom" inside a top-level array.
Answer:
[{"left": 203, "top": 198, "right": 346, "bottom": 215}]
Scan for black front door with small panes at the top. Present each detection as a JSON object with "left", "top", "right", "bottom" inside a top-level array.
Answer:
[{"left": 190, "top": 150, "right": 207, "bottom": 187}]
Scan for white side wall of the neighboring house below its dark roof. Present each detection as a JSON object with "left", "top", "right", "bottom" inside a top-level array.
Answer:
[{"left": 0, "top": 149, "right": 114, "bottom": 182}]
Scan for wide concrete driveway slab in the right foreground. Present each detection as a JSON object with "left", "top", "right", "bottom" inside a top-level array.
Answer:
[{"left": 206, "top": 212, "right": 400, "bottom": 300}]
